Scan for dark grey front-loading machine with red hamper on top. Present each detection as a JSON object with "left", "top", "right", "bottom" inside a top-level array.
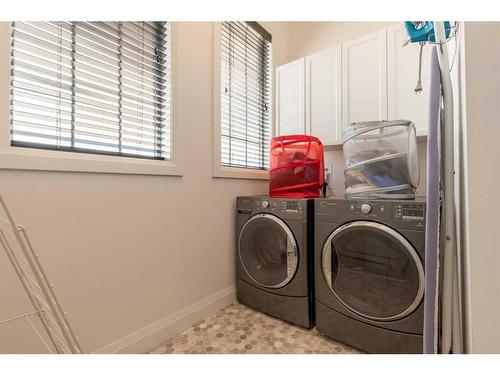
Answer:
[{"left": 236, "top": 196, "right": 314, "bottom": 328}]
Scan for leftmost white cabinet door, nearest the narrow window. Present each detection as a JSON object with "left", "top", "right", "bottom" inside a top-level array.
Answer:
[{"left": 275, "top": 58, "right": 306, "bottom": 135}]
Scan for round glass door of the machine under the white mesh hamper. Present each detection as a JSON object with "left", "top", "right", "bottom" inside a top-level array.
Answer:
[{"left": 322, "top": 221, "right": 424, "bottom": 321}]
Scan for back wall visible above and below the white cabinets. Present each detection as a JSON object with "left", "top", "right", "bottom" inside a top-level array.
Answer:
[{"left": 288, "top": 22, "right": 427, "bottom": 195}]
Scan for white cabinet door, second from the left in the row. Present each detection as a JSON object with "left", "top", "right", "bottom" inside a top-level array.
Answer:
[{"left": 306, "top": 47, "right": 342, "bottom": 145}]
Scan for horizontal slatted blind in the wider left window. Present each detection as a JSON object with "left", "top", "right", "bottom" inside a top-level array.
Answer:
[{"left": 11, "top": 22, "right": 170, "bottom": 159}]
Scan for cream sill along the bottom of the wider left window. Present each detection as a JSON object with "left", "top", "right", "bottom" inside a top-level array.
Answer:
[{"left": 0, "top": 147, "right": 183, "bottom": 176}]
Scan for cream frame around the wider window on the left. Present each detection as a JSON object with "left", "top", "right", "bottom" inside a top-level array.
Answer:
[{"left": 0, "top": 22, "right": 183, "bottom": 176}]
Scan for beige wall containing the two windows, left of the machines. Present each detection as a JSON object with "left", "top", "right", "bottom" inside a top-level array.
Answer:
[{"left": 0, "top": 22, "right": 288, "bottom": 352}]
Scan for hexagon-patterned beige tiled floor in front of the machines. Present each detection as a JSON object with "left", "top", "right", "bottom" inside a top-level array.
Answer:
[{"left": 150, "top": 303, "right": 359, "bottom": 354}]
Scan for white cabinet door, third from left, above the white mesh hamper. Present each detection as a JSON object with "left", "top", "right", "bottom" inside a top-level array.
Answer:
[{"left": 342, "top": 29, "right": 387, "bottom": 127}]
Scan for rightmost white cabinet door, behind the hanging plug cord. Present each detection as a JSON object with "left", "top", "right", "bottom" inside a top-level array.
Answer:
[{"left": 387, "top": 25, "right": 431, "bottom": 135}]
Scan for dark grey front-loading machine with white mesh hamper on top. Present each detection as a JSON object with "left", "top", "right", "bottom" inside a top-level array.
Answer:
[{"left": 314, "top": 198, "right": 426, "bottom": 353}]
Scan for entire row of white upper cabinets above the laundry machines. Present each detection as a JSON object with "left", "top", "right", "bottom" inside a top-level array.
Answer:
[{"left": 275, "top": 23, "right": 432, "bottom": 145}]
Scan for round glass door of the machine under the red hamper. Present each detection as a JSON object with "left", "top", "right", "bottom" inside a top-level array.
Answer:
[{"left": 238, "top": 214, "right": 299, "bottom": 288}]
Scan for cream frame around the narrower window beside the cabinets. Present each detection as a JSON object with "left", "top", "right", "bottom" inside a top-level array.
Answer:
[{"left": 212, "top": 22, "right": 274, "bottom": 180}]
